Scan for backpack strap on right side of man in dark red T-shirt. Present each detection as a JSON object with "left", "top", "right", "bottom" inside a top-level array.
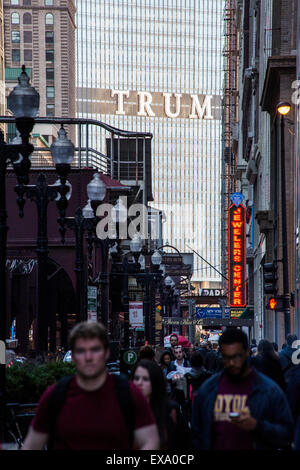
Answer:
[{"left": 113, "top": 374, "right": 135, "bottom": 449}]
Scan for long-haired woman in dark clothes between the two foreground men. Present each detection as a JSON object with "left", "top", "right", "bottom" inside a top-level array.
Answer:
[{"left": 132, "top": 359, "right": 190, "bottom": 450}]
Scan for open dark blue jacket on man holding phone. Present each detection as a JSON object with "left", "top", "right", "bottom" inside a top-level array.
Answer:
[{"left": 192, "top": 368, "right": 294, "bottom": 450}]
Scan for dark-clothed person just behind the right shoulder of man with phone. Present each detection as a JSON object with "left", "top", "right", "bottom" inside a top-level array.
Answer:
[{"left": 251, "top": 339, "right": 286, "bottom": 390}]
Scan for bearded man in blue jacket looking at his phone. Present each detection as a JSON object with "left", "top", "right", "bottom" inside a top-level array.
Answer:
[{"left": 192, "top": 328, "right": 293, "bottom": 450}]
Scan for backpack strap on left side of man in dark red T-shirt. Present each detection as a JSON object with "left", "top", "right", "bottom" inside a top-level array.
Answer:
[{"left": 47, "top": 375, "right": 74, "bottom": 450}]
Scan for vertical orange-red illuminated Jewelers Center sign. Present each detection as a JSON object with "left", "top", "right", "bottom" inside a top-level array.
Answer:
[{"left": 228, "top": 204, "right": 247, "bottom": 307}]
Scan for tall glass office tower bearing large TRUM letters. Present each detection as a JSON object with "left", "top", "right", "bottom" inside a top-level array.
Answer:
[{"left": 76, "top": 0, "right": 224, "bottom": 282}]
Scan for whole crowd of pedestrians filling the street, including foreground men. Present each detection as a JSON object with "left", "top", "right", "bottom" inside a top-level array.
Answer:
[{"left": 23, "top": 322, "right": 300, "bottom": 451}]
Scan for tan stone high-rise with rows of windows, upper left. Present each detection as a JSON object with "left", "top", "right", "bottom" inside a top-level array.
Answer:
[{"left": 4, "top": 0, "right": 75, "bottom": 126}]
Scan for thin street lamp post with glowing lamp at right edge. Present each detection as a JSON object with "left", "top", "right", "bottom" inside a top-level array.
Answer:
[{"left": 277, "top": 102, "right": 291, "bottom": 336}]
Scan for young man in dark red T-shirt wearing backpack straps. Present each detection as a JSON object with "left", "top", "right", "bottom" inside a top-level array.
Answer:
[{"left": 23, "top": 322, "right": 159, "bottom": 450}]
